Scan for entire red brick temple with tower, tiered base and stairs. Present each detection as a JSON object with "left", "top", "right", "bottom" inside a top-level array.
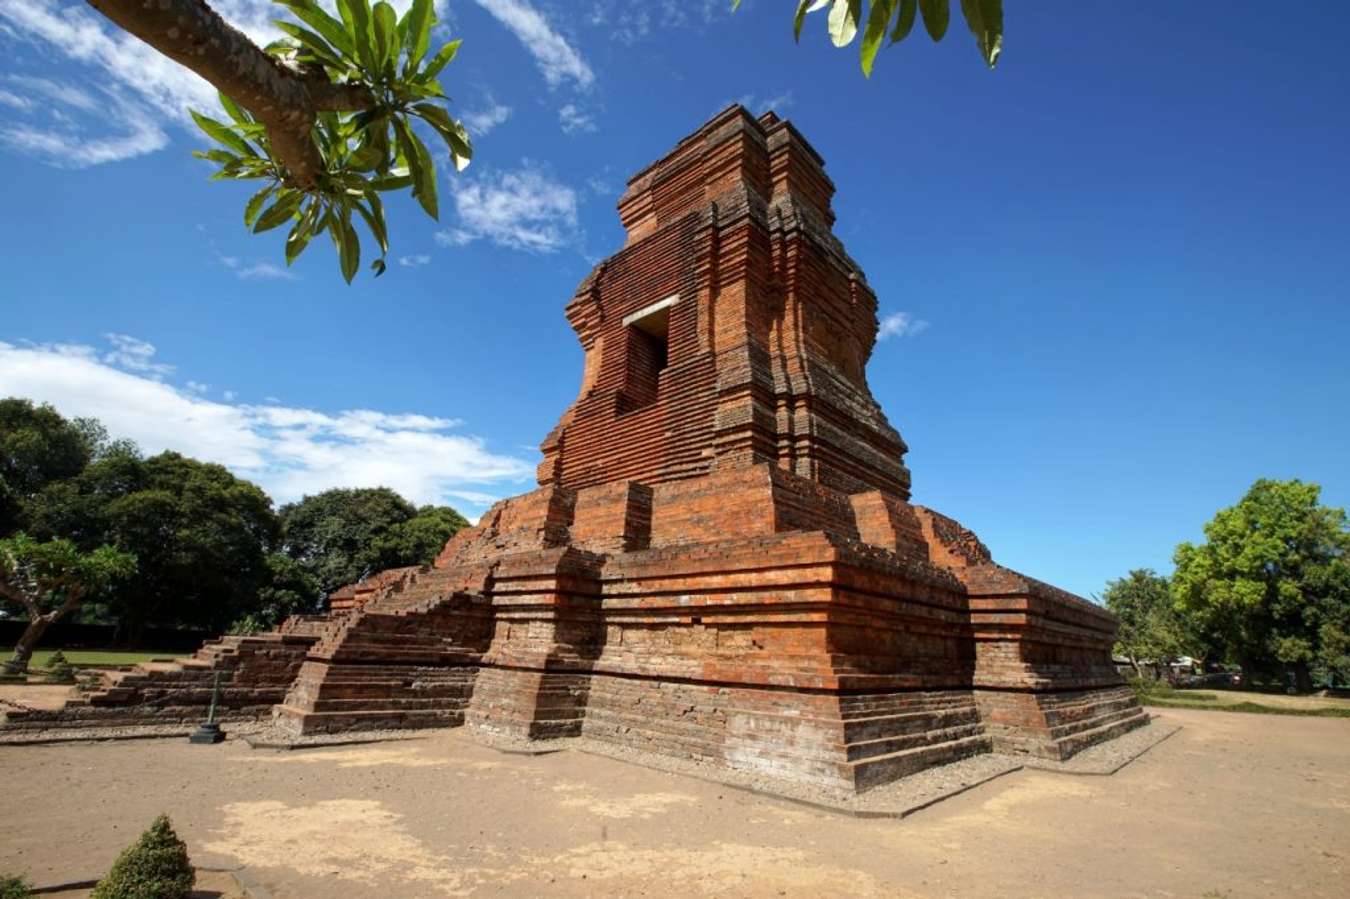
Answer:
[{"left": 0, "top": 107, "right": 1148, "bottom": 790}]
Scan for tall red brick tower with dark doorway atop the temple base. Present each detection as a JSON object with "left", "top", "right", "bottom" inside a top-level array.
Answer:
[{"left": 539, "top": 107, "right": 910, "bottom": 499}]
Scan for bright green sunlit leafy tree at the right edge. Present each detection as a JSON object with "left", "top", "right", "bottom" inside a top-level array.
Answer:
[{"left": 1172, "top": 479, "right": 1350, "bottom": 690}]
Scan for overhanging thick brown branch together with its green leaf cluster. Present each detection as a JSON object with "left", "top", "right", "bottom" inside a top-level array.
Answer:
[{"left": 89, "top": 0, "right": 473, "bottom": 282}]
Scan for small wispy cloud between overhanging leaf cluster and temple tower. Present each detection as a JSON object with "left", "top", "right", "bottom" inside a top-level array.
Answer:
[{"left": 436, "top": 159, "right": 579, "bottom": 252}]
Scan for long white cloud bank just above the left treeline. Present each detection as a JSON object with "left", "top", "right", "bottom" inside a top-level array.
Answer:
[{"left": 0, "top": 335, "right": 533, "bottom": 505}]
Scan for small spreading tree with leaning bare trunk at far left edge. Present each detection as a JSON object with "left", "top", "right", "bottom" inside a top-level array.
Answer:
[{"left": 0, "top": 533, "right": 136, "bottom": 674}]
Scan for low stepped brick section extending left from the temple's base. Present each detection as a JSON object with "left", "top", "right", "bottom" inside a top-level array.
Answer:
[{"left": 5, "top": 633, "right": 315, "bottom": 733}]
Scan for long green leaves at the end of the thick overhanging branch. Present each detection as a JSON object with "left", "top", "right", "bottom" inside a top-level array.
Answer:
[{"left": 192, "top": 0, "right": 473, "bottom": 283}]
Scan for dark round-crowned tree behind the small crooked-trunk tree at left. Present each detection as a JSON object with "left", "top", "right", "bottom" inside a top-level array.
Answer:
[{"left": 31, "top": 452, "right": 277, "bottom": 644}]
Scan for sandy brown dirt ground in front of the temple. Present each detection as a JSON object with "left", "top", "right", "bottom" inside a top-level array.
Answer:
[{"left": 0, "top": 710, "right": 1350, "bottom": 899}]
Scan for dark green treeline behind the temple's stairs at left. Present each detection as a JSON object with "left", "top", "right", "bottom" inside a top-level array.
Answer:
[{"left": 0, "top": 398, "right": 468, "bottom": 645}]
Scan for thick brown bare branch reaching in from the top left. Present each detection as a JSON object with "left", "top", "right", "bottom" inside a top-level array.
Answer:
[{"left": 89, "top": 0, "right": 374, "bottom": 190}]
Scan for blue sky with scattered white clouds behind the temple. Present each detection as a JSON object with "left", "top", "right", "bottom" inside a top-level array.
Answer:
[{"left": 0, "top": 0, "right": 1350, "bottom": 594}]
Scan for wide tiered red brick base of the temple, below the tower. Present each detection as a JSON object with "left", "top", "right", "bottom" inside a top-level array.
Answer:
[{"left": 263, "top": 466, "right": 1146, "bottom": 790}]
